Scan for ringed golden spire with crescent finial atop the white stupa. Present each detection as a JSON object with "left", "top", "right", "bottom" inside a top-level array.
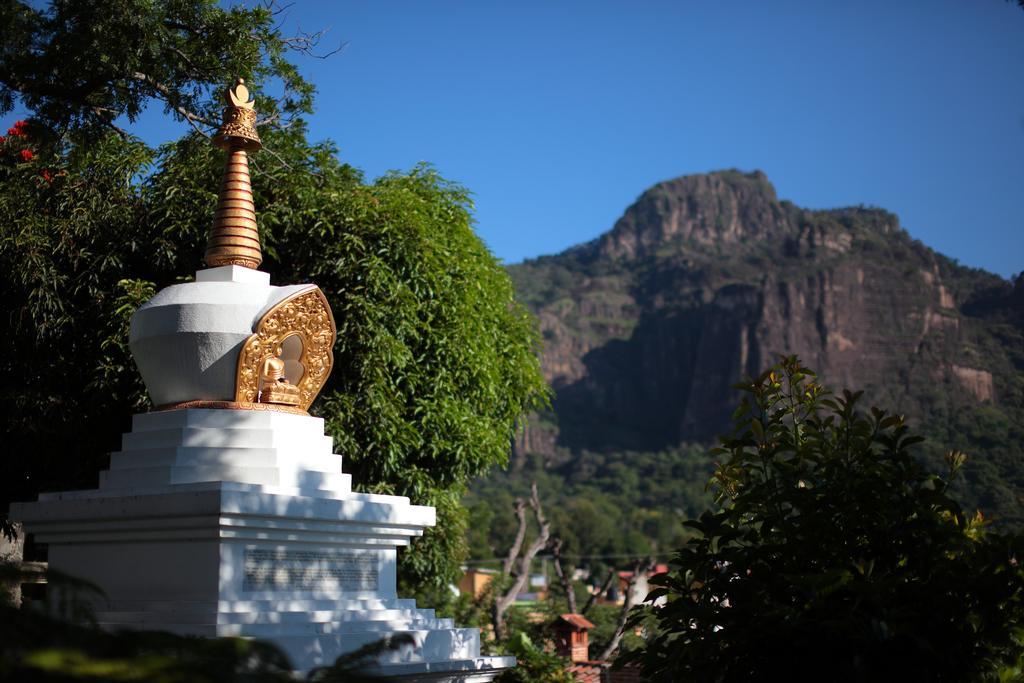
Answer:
[{"left": 204, "top": 78, "right": 263, "bottom": 268}]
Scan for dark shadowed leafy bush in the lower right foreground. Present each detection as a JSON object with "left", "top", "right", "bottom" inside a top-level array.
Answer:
[{"left": 634, "top": 357, "right": 1024, "bottom": 681}]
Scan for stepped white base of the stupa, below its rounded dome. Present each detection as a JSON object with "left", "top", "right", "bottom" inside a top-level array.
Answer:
[{"left": 11, "top": 409, "right": 515, "bottom": 682}]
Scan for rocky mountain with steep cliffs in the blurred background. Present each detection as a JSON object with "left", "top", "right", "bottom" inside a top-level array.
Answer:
[{"left": 468, "top": 171, "right": 1024, "bottom": 548}]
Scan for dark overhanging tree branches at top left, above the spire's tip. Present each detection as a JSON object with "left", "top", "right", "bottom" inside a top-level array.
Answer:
[{"left": 0, "top": 0, "right": 323, "bottom": 136}]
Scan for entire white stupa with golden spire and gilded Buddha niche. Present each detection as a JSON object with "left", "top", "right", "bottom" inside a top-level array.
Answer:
[{"left": 11, "top": 80, "right": 515, "bottom": 683}]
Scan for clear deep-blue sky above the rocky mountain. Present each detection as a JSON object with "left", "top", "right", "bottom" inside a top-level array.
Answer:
[{"left": 8, "top": 0, "right": 1024, "bottom": 275}]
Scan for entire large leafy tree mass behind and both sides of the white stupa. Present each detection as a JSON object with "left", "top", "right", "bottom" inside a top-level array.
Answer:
[{"left": 0, "top": 0, "right": 546, "bottom": 596}]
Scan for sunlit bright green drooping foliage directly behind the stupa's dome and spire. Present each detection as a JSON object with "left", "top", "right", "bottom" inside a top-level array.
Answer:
[{"left": 149, "top": 136, "right": 547, "bottom": 595}]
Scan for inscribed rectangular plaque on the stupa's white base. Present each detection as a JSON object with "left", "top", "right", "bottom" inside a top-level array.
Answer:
[{"left": 242, "top": 548, "right": 380, "bottom": 591}]
